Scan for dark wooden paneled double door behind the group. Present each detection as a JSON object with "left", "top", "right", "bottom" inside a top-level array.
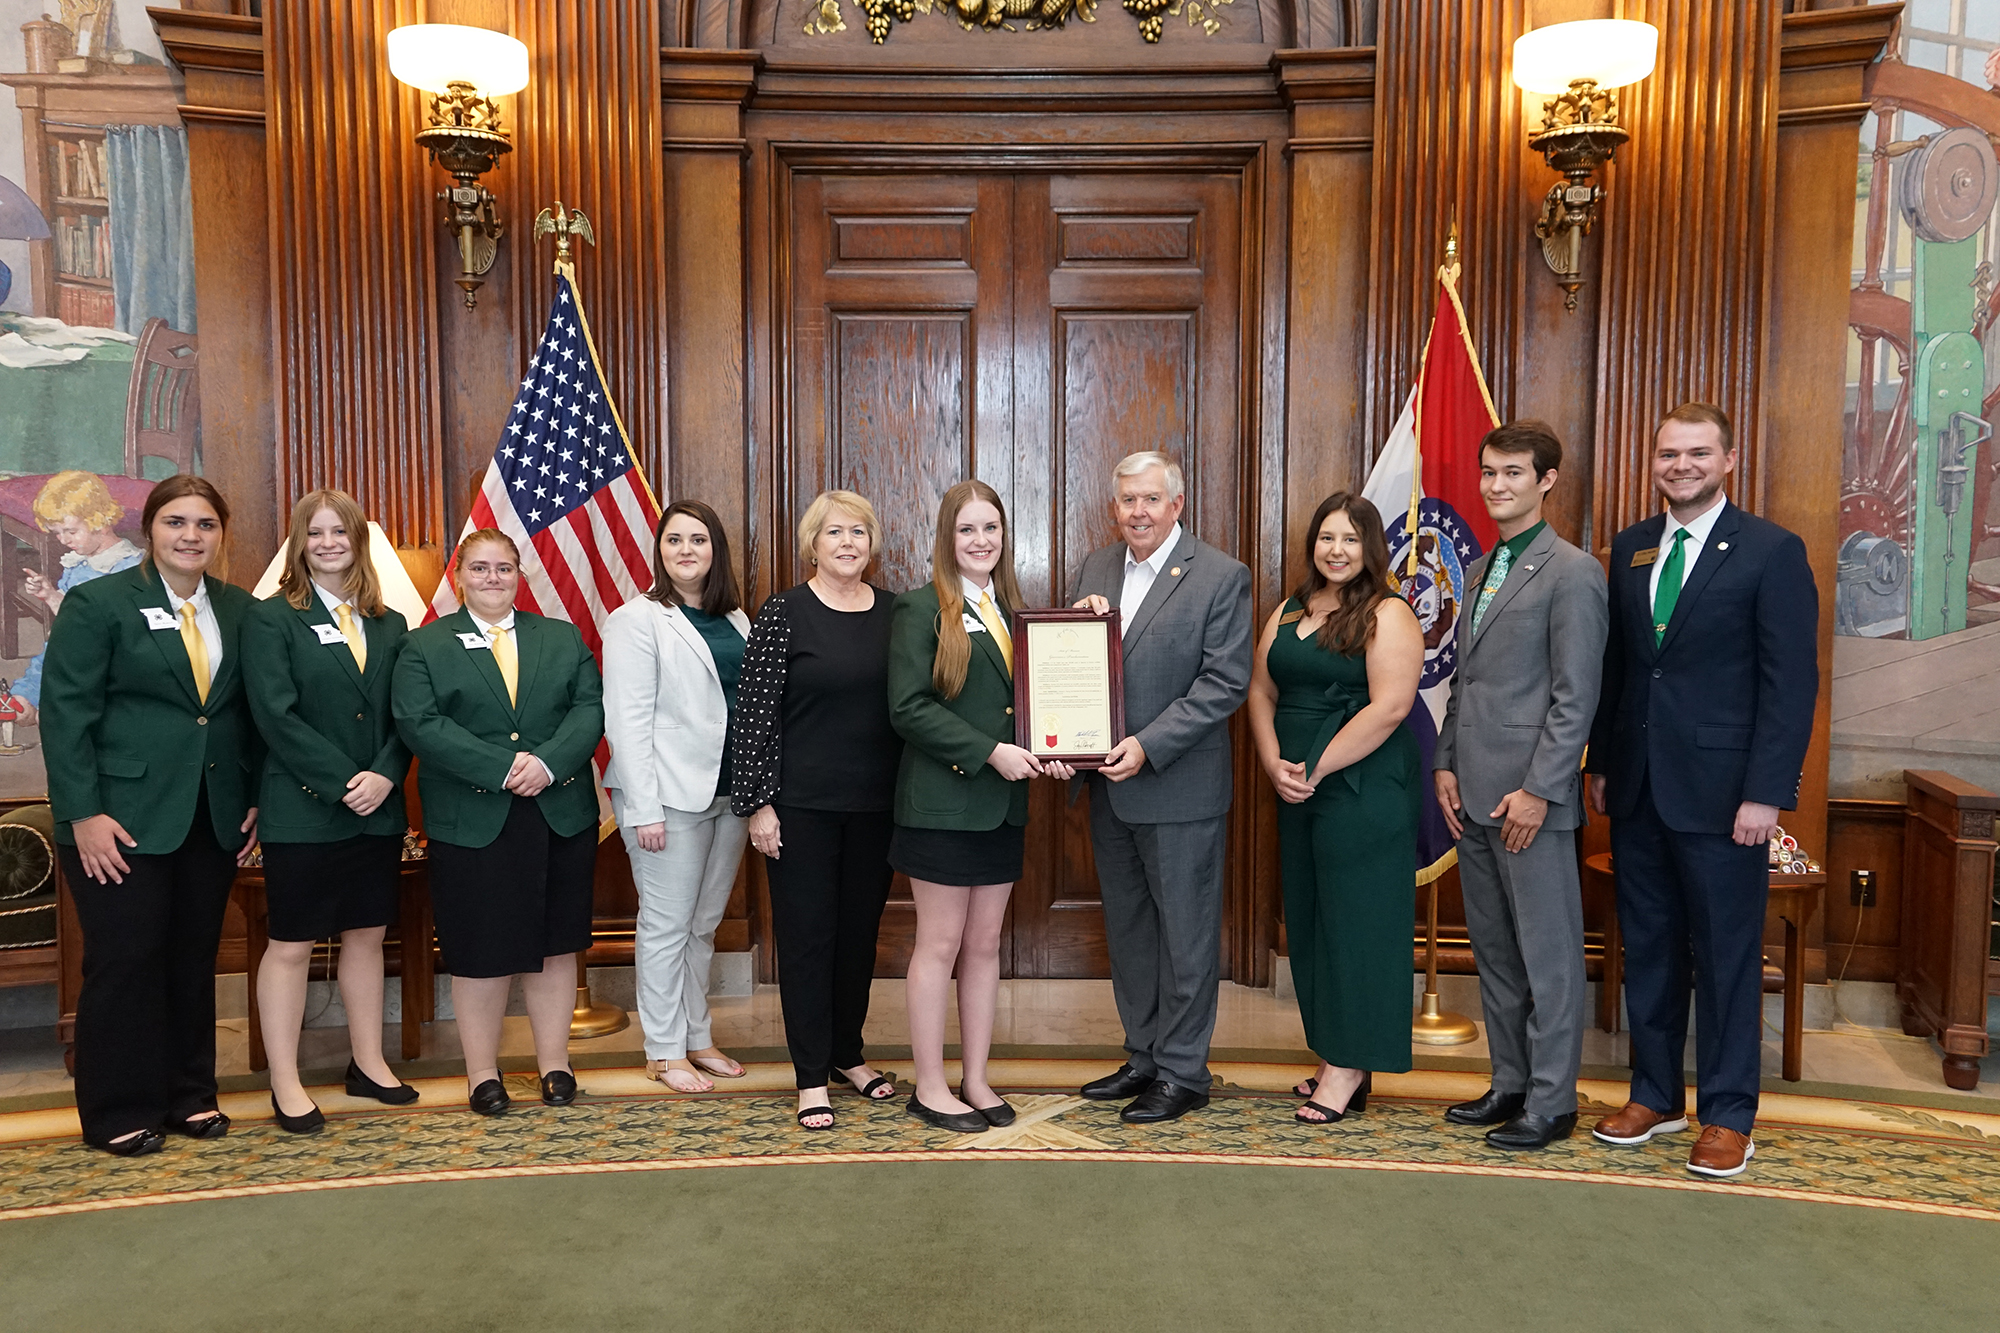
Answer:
[{"left": 778, "top": 168, "right": 1246, "bottom": 977}]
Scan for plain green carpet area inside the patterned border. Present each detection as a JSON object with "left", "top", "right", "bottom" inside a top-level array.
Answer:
[{"left": 0, "top": 1161, "right": 2000, "bottom": 1333}]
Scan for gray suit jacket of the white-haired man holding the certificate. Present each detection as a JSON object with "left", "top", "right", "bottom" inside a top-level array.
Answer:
[{"left": 1068, "top": 528, "right": 1240, "bottom": 825}]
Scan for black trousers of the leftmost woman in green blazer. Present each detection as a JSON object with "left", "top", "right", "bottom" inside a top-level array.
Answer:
[{"left": 60, "top": 793, "right": 236, "bottom": 1145}]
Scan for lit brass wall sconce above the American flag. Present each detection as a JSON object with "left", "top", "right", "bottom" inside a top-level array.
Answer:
[{"left": 388, "top": 24, "right": 528, "bottom": 310}]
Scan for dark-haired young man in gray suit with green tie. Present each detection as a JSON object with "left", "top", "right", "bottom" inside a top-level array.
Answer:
[{"left": 1432, "top": 420, "right": 1608, "bottom": 1149}]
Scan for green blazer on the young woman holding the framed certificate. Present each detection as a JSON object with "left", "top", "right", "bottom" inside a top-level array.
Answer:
[{"left": 888, "top": 582, "right": 1028, "bottom": 831}]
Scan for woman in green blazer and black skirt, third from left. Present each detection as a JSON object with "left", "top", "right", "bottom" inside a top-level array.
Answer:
[{"left": 392, "top": 528, "right": 604, "bottom": 1115}]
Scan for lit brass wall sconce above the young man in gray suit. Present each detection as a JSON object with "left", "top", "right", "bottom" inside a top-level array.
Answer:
[{"left": 1514, "top": 18, "right": 1660, "bottom": 310}]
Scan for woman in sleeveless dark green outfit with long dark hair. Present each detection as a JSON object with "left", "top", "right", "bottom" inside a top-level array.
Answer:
[{"left": 1250, "top": 492, "right": 1424, "bottom": 1125}]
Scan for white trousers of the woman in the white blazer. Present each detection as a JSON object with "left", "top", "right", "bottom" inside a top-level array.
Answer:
[{"left": 612, "top": 793, "right": 750, "bottom": 1061}]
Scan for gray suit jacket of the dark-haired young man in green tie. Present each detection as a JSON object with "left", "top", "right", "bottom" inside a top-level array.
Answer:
[{"left": 1430, "top": 528, "right": 1608, "bottom": 829}]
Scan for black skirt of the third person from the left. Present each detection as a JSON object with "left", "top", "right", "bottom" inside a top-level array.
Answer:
[{"left": 430, "top": 797, "right": 598, "bottom": 977}]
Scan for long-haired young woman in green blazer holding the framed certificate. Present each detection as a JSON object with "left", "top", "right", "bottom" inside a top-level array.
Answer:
[{"left": 888, "top": 480, "right": 1072, "bottom": 1133}]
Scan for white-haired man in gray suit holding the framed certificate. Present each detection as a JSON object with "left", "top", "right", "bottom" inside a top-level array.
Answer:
[{"left": 1076, "top": 452, "right": 1250, "bottom": 1125}]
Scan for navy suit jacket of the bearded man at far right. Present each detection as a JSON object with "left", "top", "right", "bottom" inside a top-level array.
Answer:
[{"left": 1584, "top": 500, "right": 1820, "bottom": 835}]
